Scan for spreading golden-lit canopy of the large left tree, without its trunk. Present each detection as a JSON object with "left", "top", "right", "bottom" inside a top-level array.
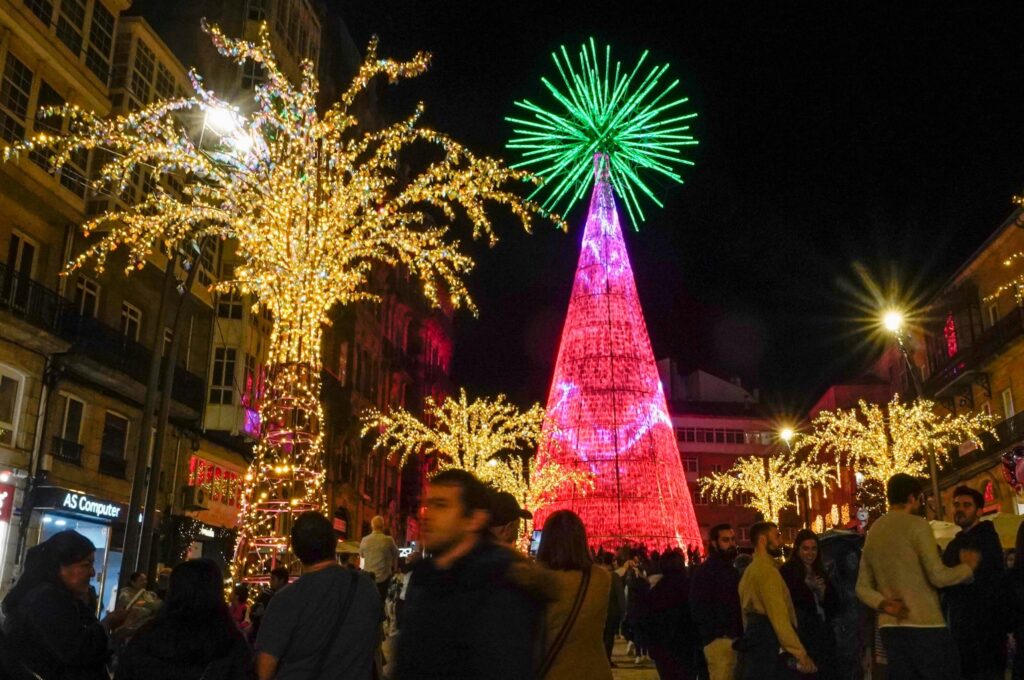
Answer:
[{"left": 7, "top": 22, "right": 561, "bottom": 362}]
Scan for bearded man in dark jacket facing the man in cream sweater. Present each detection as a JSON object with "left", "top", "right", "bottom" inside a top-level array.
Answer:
[{"left": 942, "top": 486, "right": 1007, "bottom": 680}]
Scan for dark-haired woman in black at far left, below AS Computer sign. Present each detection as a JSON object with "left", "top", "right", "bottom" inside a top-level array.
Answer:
[{"left": 0, "top": 530, "right": 127, "bottom": 680}]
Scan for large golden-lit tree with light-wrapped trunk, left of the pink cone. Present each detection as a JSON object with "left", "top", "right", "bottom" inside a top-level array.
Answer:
[{"left": 6, "top": 27, "right": 561, "bottom": 580}]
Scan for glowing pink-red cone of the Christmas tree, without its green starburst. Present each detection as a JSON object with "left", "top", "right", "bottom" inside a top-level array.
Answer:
[{"left": 535, "top": 163, "right": 702, "bottom": 550}]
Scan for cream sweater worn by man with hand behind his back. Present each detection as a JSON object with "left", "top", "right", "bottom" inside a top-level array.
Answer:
[{"left": 857, "top": 510, "right": 973, "bottom": 628}]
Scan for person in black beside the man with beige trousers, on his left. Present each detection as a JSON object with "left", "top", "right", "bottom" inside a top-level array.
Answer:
[{"left": 647, "top": 549, "right": 699, "bottom": 680}]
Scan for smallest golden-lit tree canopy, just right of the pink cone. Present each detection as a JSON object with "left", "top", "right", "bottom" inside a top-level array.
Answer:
[{"left": 698, "top": 449, "right": 836, "bottom": 521}]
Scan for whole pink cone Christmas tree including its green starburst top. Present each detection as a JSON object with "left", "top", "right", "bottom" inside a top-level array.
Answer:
[{"left": 509, "top": 41, "right": 702, "bottom": 549}]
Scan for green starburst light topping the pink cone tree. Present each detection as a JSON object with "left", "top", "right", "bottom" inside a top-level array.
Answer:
[{"left": 507, "top": 38, "right": 697, "bottom": 225}]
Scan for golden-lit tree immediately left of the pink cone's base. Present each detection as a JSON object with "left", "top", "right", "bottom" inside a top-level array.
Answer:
[{"left": 362, "top": 389, "right": 593, "bottom": 510}]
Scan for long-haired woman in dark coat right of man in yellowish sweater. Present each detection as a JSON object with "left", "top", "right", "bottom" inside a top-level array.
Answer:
[{"left": 779, "top": 528, "right": 839, "bottom": 680}]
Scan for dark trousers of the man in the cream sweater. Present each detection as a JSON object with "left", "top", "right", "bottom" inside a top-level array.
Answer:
[{"left": 882, "top": 626, "right": 962, "bottom": 680}]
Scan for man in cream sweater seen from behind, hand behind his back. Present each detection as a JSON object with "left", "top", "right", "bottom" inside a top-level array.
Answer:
[{"left": 857, "top": 474, "right": 981, "bottom": 680}]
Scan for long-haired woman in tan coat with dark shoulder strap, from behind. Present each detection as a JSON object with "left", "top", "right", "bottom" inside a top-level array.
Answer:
[{"left": 537, "top": 510, "right": 611, "bottom": 680}]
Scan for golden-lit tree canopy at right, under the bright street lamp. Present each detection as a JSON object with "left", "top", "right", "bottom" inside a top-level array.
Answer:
[{"left": 799, "top": 394, "right": 995, "bottom": 485}]
